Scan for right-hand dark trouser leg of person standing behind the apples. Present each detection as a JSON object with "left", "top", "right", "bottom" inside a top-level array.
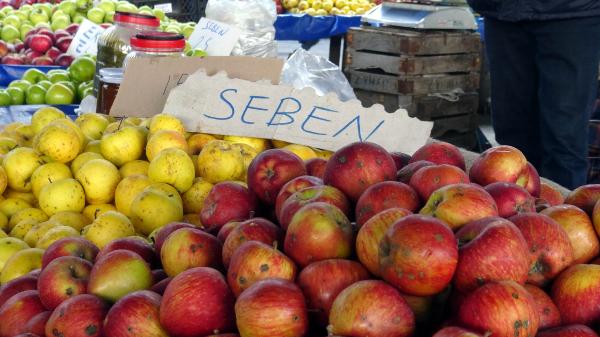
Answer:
[{"left": 531, "top": 17, "right": 600, "bottom": 188}]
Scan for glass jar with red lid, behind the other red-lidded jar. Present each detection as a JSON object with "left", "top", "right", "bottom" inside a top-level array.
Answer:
[{"left": 94, "top": 12, "right": 160, "bottom": 94}]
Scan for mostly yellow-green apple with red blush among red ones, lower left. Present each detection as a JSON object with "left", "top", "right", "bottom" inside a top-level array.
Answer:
[{"left": 88, "top": 249, "right": 152, "bottom": 302}]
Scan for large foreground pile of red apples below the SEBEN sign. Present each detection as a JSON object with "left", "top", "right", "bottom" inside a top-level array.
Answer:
[{"left": 5, "top": 143, "right": 600, "bottom": 337}]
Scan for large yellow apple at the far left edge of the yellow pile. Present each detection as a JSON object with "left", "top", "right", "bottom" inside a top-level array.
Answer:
[{"left": 3, "top": 147, "right": 44, "bottom": 192}]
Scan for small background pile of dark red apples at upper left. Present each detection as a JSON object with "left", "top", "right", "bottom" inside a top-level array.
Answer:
[{"left": 0, "top": 23, "right": 79, "bottom": 67}]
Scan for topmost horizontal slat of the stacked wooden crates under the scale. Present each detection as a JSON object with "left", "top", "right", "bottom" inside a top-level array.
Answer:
[{"left": 346, "top": 27, "right": 480, "bottom": 55}]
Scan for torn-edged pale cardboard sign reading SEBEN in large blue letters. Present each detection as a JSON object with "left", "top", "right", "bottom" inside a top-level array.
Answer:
[{"left": 163, "top": 70, "right": 433, "bottom": 154}]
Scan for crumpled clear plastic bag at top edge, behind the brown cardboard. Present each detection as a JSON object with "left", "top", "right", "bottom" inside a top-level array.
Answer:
[{"left": 206, "top": 0, "right": 277, "bottom": 57}]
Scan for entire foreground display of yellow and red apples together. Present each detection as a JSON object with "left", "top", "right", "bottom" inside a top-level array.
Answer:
[{"left": 0, "top": 108, "right": 600, "bottom": 337}]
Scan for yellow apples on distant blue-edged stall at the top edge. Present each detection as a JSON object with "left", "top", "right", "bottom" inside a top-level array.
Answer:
[{"left": 282, "top": 0, "right": 375, "bottom": 15}]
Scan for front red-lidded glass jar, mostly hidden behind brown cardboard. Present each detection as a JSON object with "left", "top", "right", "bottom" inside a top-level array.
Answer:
[{"left": 123, "top": 32, "right": 185, "bottom": 67}]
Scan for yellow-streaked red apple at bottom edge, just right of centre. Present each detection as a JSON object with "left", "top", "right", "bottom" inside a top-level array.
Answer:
[{"left": 328, "top": 280, "right": 415, "bottom": 337}]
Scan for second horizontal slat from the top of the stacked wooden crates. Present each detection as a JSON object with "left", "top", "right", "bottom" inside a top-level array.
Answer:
[{"left": 345, "top": 49, "right": 481, "bottom": 75}]
